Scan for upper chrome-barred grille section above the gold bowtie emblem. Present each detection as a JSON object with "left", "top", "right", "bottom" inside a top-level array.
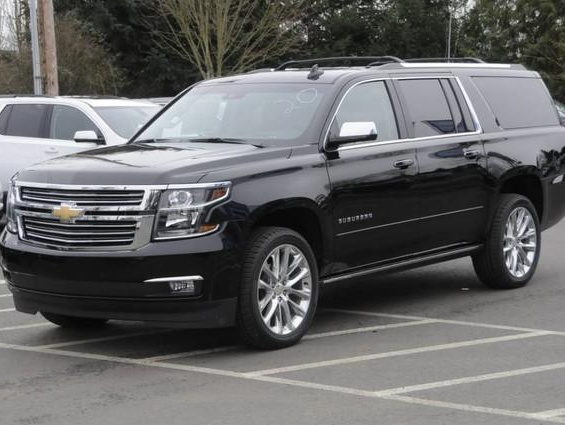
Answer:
[{"left": 21, "top": 187, "right": 145, "bottom": 207}]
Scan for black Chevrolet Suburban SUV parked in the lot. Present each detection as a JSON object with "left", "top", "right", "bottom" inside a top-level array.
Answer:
[{"left": 0, "top": 57, "right": 565, "bottom": 348}]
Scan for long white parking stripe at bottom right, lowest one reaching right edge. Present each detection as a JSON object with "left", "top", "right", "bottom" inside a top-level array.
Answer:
[{"left": 375, "top": 362, "right": 565, "bottom": 396}]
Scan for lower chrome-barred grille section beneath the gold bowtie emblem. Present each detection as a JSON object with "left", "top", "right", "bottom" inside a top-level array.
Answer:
[{"left": 22, "top": 216, "right": 138, "bottom": 247}]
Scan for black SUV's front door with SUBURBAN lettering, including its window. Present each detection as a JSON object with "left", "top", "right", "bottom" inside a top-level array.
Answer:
[{"left": 326, "top": 80, "right": 418, "bottom": 272}]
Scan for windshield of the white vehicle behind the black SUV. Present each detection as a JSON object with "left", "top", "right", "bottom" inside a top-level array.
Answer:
[{"left": 94, "top": 105, "right": 161, "bottom": 139}]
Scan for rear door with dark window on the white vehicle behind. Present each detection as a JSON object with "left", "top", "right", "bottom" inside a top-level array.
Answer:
[{"left": 0, "top": 104, "right": 50, "bottom": 187}]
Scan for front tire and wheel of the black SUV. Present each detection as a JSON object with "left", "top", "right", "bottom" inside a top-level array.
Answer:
[{"left": 237, "top": 227, "right": 318, "bottom": 349}]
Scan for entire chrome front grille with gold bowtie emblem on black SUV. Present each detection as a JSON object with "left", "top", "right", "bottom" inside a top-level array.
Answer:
[{"left": 15, "top": 182, "right": 162, "bottom": 251}]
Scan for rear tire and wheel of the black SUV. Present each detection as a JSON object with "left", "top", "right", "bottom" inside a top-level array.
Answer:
[{"left": 473, "top": 194, "right": 541, "bottom": 289}]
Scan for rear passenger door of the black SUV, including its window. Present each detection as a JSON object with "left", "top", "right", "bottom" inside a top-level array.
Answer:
[{"left": 395, "top": 76, "right": 489, "bottom": 252}]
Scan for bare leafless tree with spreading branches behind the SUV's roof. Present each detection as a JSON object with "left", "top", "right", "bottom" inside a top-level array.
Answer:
[{"left": 155, "top": 0, "right": 307, "bottom": 78}]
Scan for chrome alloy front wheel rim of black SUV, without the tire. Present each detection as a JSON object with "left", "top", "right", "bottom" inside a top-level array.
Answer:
[{"left": 257, "top": 244, "right": 312, "bottom": 335}]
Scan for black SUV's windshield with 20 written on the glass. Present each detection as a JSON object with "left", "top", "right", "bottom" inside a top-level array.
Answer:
[{"left": 133, "top": 84, "right": 326, "bottom": 144}]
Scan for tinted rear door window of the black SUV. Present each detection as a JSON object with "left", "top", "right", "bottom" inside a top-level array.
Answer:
[{"left": 398, "top": 79, "right": 461, "bottom": 137}]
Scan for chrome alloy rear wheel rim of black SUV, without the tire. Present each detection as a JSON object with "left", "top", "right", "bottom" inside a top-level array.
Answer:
[{"left": 503, "top": 207, "right": 538, "bottom": 278}]
